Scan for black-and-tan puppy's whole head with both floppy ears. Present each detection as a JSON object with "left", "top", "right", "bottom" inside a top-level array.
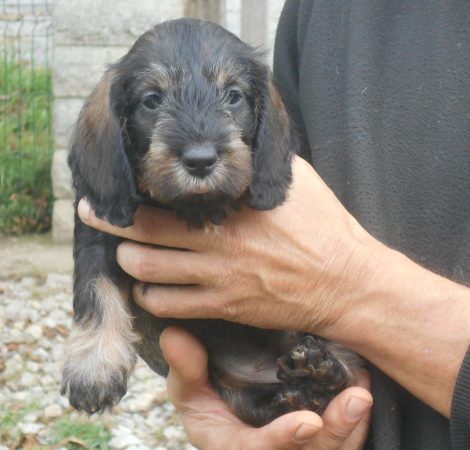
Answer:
[{"left": 69, "top": 19, "right": 297, "bottom": 225}]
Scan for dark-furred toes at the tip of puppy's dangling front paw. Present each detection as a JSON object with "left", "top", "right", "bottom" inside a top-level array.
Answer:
[{"left": 61, "top": 361, "right": 129, "bottom": 414}]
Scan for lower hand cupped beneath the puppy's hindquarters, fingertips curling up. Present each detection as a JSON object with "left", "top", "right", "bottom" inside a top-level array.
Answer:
[{"left": 160, "top": 327, "right": 372, "bottom": 450}]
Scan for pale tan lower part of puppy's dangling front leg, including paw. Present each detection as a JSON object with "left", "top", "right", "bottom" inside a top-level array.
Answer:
[{"left": 61, "top": 276, "right": 139, "bottom": 414}]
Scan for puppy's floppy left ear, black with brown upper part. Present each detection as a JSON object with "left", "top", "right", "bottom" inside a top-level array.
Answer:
[{"left": 68, "top": 72, "right": 136, "bottom": 227}]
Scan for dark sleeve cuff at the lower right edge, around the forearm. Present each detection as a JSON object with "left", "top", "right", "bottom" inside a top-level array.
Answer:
[{"left": 450, "top": 347, "right": 470, "bottom": 450}]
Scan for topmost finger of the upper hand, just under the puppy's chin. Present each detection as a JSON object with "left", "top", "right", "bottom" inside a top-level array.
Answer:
[{"left": 77, "top": 198, "right": 207, "bottom": 250}]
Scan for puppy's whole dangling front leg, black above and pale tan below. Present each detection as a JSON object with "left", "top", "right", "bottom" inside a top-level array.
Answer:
[{"left": 61, "top": 223, "right": 138, "bottom": 414}]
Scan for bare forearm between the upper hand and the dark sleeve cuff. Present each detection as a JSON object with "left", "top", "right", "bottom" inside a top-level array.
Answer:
[{"left": 323, "top": 243, "right": 470, "bottom": 416}]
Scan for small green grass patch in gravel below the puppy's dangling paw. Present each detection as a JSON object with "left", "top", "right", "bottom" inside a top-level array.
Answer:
[{"left": 52, "top": 418, "right": 111, "bottom": 450}]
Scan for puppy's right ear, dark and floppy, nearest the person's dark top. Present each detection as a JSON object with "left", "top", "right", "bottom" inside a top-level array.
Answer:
[{"left": 246, "top": 76, "right": 298, "bottom": 210}]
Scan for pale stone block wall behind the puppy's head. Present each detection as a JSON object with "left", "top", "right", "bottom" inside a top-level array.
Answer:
[{"left": 52, "top": 0, "right": 283, "bottom": 243}]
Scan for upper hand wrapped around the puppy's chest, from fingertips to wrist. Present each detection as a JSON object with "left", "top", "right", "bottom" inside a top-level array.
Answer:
[{"left": 78, "top": 157, "right": 373, "bottom": 337}]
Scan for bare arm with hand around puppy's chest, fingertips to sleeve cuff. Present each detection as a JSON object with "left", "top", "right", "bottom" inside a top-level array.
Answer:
[{"left": 79, "top": 158, "right": 470, "bottom": 416}]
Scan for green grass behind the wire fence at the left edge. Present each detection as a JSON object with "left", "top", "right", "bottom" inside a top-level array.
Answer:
[{"left": 0, "top": 52, "right": 52, "bottom": 234}]
